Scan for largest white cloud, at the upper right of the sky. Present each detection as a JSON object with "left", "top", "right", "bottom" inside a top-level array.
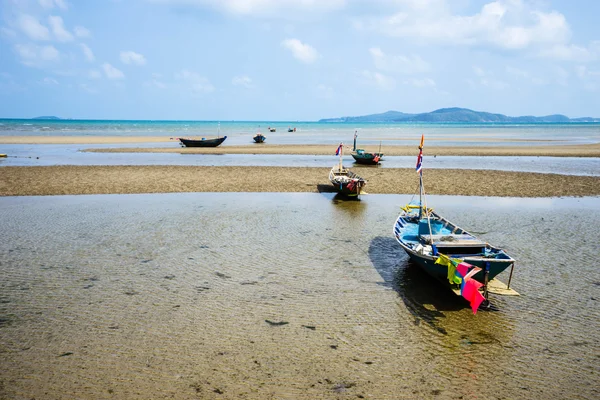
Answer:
[{"left": 354, "top": 0, "right": 587, "bottom": 60}]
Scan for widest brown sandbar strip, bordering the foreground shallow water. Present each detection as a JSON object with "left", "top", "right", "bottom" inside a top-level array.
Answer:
[{"left": 0, "top": 166, "right": 600, "bottom": 197}]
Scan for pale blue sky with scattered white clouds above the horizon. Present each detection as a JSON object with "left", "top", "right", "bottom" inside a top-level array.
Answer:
[{"left": 0, "top": 0, "right": 600, "bottom": 121}]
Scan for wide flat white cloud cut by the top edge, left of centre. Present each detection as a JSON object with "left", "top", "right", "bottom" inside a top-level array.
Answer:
[{"left": 148, "top": 0, "right": 347, "bottom": 18}]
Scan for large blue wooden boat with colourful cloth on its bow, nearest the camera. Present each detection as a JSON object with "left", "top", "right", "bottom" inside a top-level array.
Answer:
[{"left": 394, "top": 136, "right": 518, "bottom": 313}]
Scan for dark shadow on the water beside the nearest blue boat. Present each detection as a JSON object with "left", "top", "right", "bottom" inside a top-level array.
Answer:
[{"left": 369, "top": 236, "right": 466, "bottom": 334}]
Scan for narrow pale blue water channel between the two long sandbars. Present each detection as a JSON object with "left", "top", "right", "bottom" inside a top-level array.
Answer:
[{"left": 0, "top": 143, "right": 600, "bottom": 176}]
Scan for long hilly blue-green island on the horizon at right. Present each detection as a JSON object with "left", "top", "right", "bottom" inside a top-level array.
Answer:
[{"left": 319, "top": 107, "right": 600, "bottom": 124}]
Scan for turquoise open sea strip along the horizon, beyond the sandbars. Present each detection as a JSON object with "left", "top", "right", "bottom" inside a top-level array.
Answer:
[{"left": 0, "top": 119, "right": 600, "bottom": 150}]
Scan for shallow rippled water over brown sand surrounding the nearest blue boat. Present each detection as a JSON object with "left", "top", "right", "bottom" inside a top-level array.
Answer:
[{"left": 0, "top": 193, "right": 600, "bottom": 399}]
